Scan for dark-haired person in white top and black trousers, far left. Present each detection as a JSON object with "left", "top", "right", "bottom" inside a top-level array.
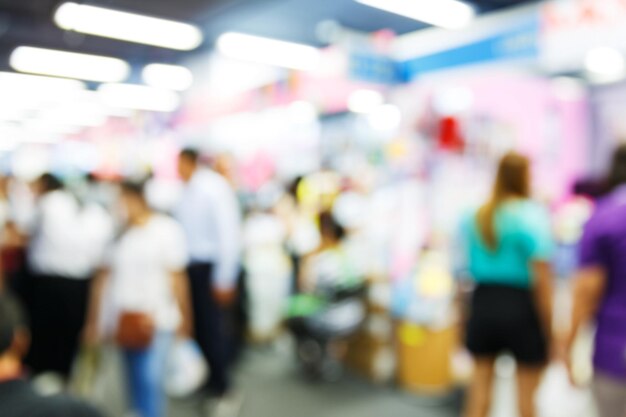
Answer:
[{"left": 24, "top": 174, "right": 112, "bottom": 380}]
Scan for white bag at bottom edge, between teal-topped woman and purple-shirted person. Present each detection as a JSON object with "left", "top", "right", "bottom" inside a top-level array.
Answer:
[{"left": 537, "top": 364, "right": 594, "bottom": 417}]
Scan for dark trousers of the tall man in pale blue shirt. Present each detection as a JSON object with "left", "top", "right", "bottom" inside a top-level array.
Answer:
[{"left": 187, "top": 263, "right": 230, "bottom": 396}]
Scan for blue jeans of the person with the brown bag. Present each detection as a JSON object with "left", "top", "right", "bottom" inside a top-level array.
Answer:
[{"left": 124, "top": 332, "right": 173, "bottom": 417}]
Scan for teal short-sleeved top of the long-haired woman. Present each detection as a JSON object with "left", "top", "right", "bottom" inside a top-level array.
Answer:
[{"left": 461, "top": 200, "right": 554, "bottom": 288}]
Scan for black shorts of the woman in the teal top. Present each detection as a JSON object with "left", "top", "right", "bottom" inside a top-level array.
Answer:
[{"left": 466, "top": 284, "right": 548, "bottom": 366}]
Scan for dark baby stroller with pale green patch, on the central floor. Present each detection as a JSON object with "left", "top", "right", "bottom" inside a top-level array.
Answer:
[{"left": 287, "top": 285, "right": 366, "bottom": 381}]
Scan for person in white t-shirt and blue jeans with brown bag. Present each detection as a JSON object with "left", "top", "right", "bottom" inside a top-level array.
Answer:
[{"left": 84, "top": 183, "right": 192, "bottom": 417}]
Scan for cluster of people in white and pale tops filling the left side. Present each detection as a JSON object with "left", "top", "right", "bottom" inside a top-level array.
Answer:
[{"left": 1, "top": 149, "right": 241, "bottom": 417}]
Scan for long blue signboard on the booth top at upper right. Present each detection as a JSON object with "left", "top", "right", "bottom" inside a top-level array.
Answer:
[{"left": 399, "top": 19, "right": 540, "bottom": 82}]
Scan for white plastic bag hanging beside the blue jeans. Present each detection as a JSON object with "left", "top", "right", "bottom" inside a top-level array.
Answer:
[{"left": 165, "top": 340, "right": 209, "bottom": 398}]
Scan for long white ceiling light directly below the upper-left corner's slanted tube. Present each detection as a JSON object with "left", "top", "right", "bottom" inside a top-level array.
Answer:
[{"left": 10, "top": 46, "right": 130, "bottom": 82}]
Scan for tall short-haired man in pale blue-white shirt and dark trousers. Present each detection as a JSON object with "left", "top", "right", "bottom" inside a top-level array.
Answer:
[{"left": 175, "top": 149, "right": 241, "bottom": 398}]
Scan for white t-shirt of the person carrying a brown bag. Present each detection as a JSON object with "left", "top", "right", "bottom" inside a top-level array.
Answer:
[{"left": 108, "top": 214, "right": 187, "bottom": 331}]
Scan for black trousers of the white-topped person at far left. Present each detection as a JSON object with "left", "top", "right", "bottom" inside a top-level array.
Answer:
[{"left": 23, "top": 275, "right": 90, "bottom": 379}]
